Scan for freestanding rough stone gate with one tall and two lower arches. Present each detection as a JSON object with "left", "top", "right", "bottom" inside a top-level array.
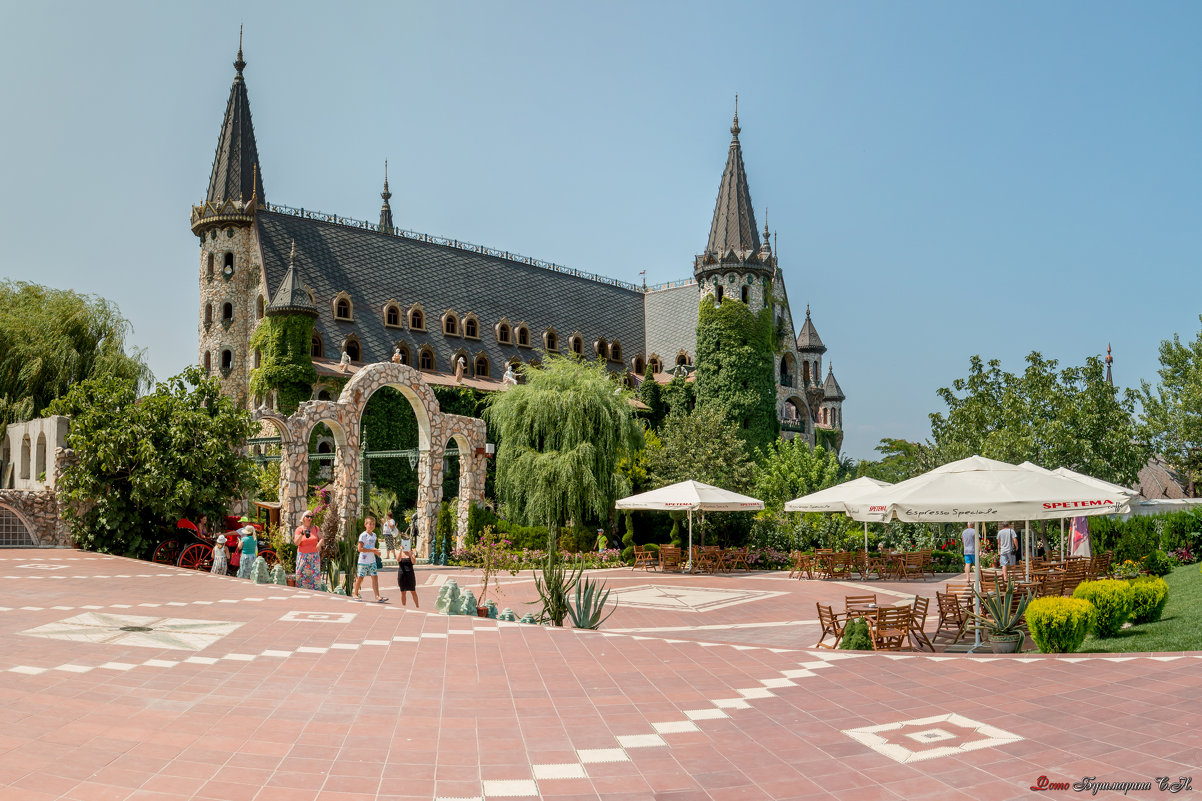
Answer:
[{"left": 255, "top": 362, "right": 486, "bottom": 556}]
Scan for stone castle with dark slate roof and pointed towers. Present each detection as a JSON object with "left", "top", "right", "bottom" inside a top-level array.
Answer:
[{"left": 191, "top": 46, "right": 844, "bottom": 446}]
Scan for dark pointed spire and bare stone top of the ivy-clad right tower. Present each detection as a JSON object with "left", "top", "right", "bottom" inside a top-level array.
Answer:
[{"left": 692, "top": 100, "right": 775, "bottom": 313}]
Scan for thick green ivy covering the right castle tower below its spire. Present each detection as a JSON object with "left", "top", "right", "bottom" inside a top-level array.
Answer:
[{"left": 696, "top": 296, "right": 780, "bottom": 453}]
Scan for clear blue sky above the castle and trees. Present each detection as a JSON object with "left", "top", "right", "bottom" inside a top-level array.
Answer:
[{"left": 0, "top": 0, "right": 1202, "bottom": 458}]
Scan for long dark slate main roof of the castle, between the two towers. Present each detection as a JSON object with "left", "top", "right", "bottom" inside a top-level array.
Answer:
[{"left": 255, "top": 209, "right": 645, "bottom": 378}]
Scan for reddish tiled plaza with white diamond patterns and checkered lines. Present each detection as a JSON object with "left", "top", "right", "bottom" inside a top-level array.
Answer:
[{"left": 0, "top": 550, "right": 1202, "bottom": 801}]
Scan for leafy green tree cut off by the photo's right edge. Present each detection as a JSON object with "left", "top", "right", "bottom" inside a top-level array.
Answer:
[{"left": 1139, "top": 315, "right": 1202, "bottom": 497}]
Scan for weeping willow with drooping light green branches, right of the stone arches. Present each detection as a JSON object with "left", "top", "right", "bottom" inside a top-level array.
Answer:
[{"left": 484, "top": 355, "right": 642, "bottom": 536}]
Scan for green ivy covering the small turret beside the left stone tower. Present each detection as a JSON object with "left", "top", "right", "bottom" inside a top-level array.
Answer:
[{"left": 250, "top": 314, "right": 317, "bottom": 415}]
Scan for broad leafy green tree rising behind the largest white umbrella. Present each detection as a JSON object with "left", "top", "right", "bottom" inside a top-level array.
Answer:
[{"left": 930, "top": 352, "right": 1148, "bottom": 485}]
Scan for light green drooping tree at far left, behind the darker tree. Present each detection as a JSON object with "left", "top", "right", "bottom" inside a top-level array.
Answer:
[{"left": 0, "top": 281, "right": 154, "bottom": 428}]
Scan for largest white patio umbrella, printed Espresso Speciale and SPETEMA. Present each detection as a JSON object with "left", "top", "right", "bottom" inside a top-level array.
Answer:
[{"left": 849, "top": 456, "right": 1130, "bottom": 648}]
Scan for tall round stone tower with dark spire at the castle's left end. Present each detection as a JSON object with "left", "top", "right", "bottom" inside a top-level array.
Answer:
[{"left": 192, "top": 34, "right": 266, "bottom": 404}]
